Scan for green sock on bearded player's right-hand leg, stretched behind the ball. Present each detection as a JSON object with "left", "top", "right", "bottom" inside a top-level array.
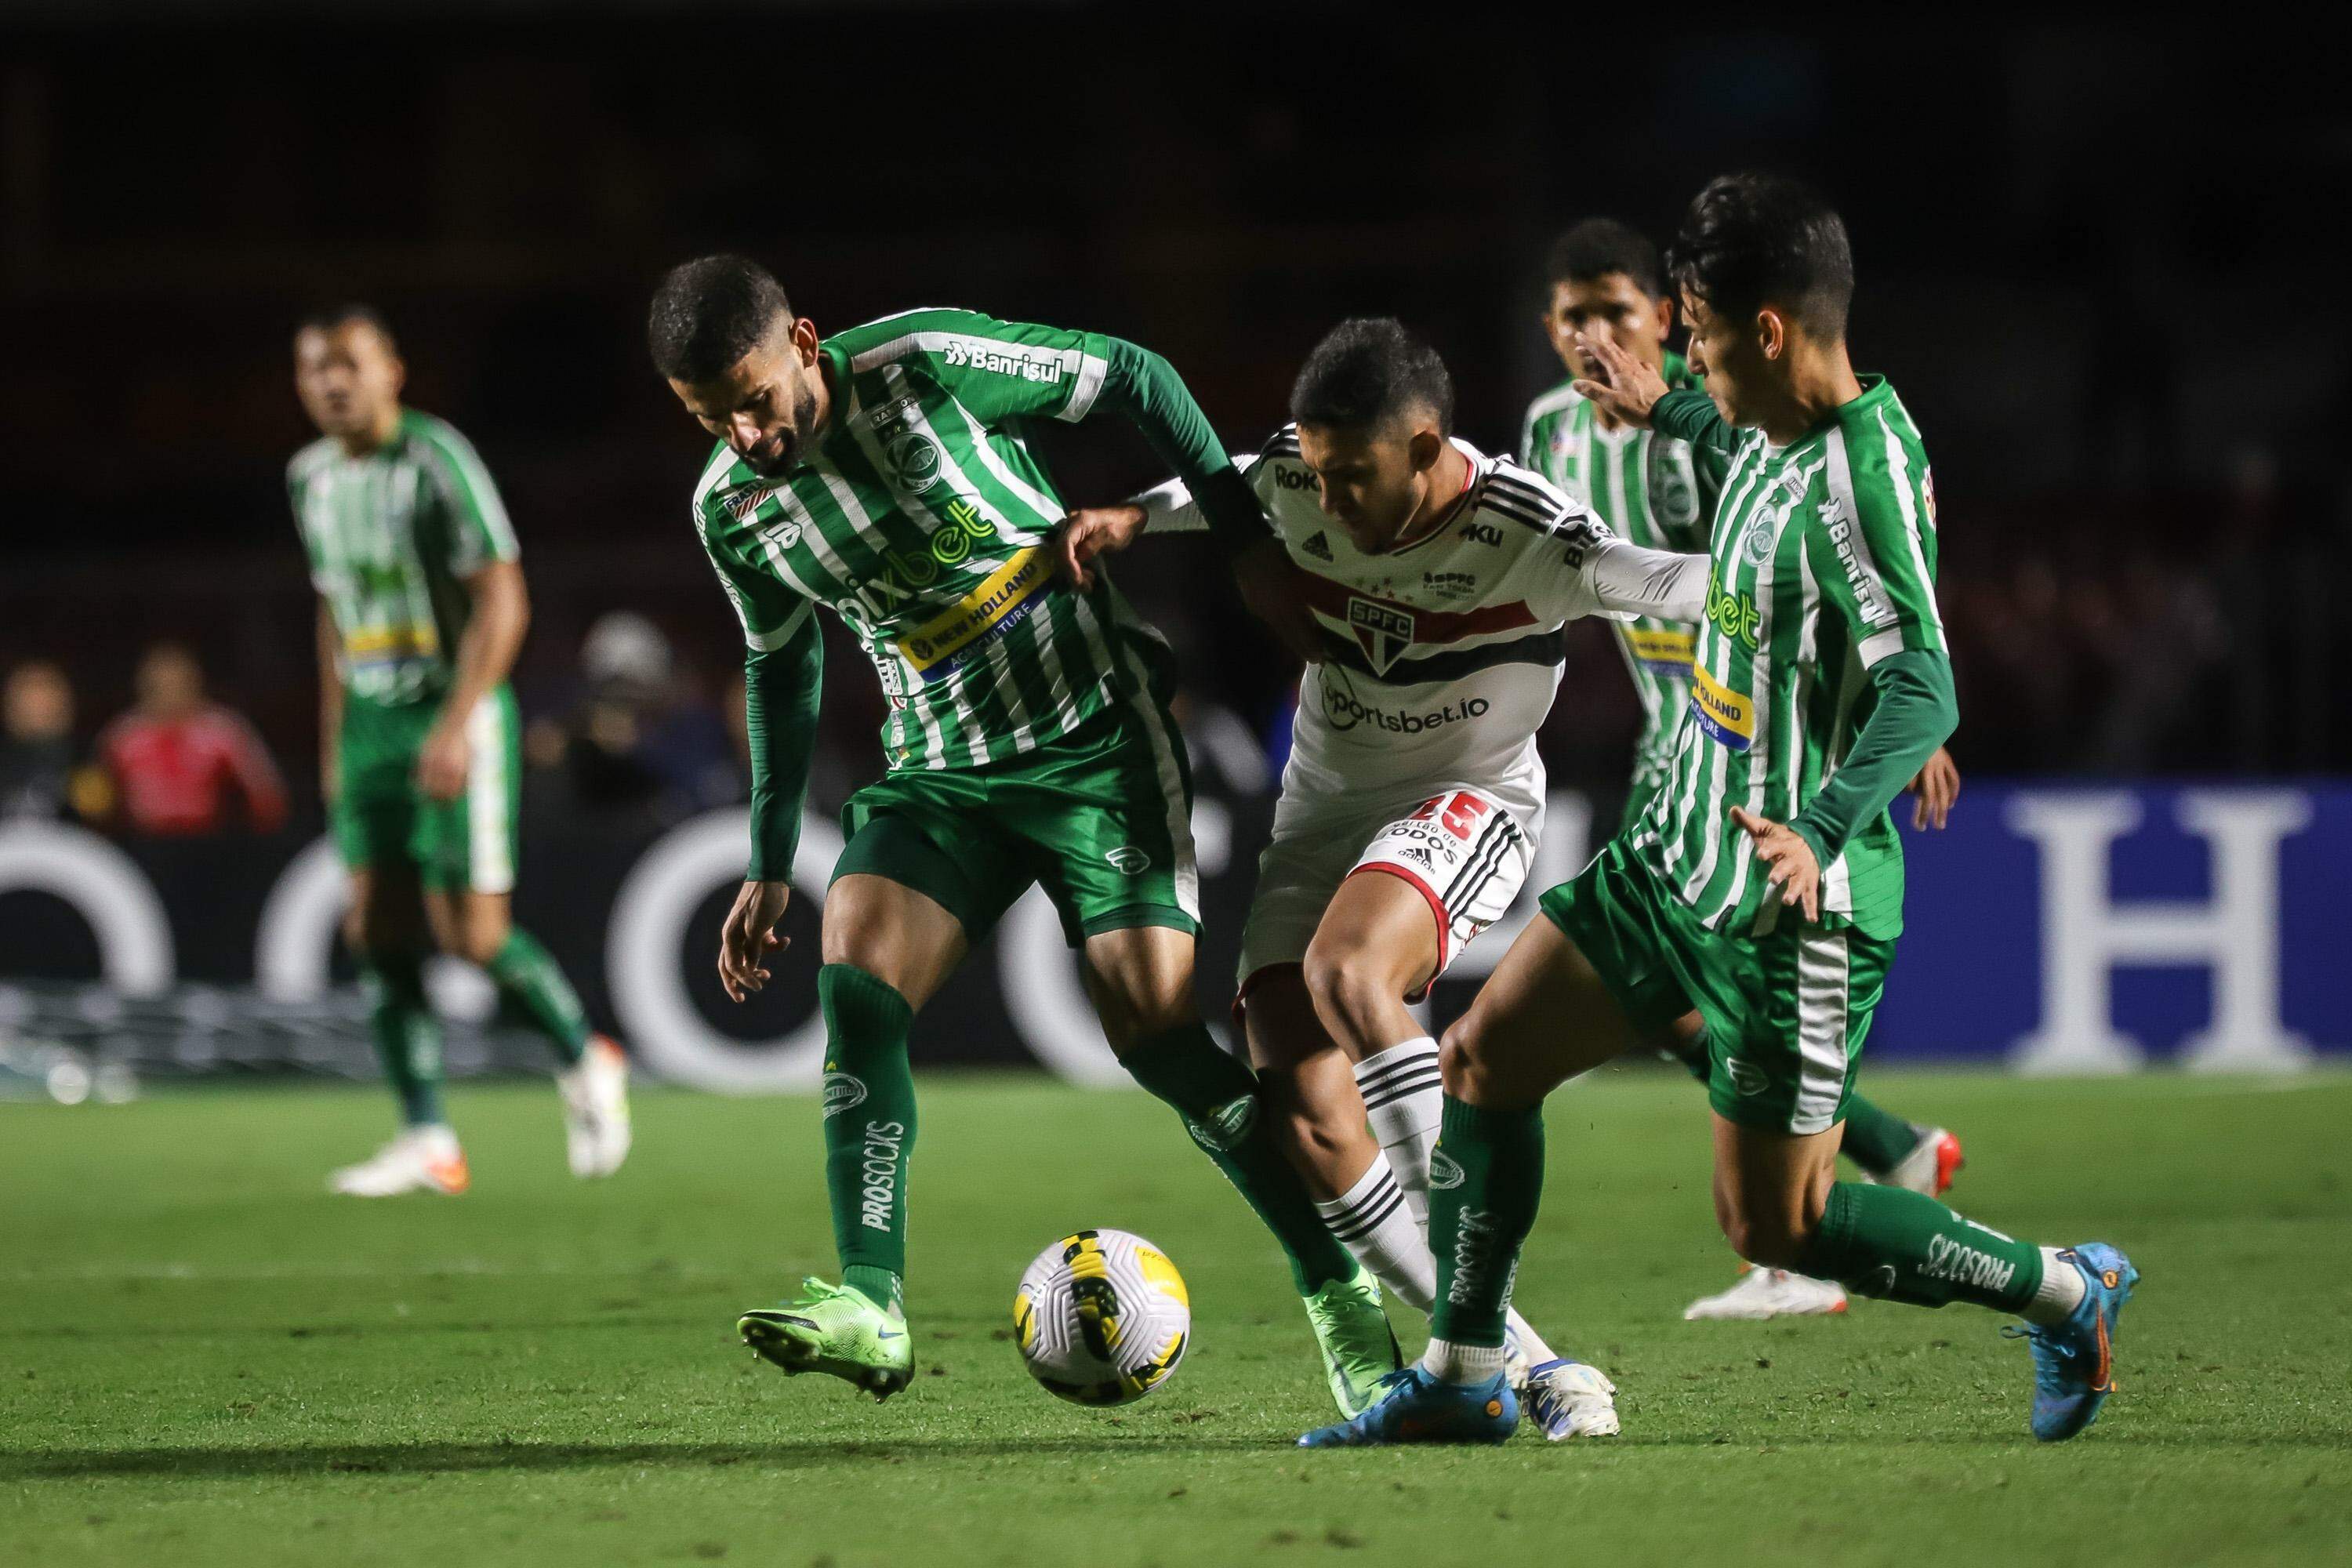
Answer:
[{"left": 1120, "top": 1022, "right": 1355, "bottom": 1295}]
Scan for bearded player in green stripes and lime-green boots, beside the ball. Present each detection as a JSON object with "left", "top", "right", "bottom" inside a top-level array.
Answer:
[{"left": 647, "top": 256, "right": 1397, "bottom": 1413}]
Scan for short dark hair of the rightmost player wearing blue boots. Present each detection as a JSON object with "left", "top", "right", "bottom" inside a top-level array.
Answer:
[{"left": 1665, "top": 174, "right": 1853, "bottom": 339}]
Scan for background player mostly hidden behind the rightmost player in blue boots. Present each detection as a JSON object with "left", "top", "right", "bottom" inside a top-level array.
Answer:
[{"left": 1519, "top": 219, "right": 1962, "bottom": 1319}]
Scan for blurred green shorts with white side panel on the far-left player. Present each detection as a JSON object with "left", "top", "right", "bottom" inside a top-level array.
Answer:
[{"left": 332, "top": 687, "right": 522, "bottom": 893}]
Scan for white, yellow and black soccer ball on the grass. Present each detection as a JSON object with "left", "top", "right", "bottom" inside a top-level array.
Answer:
[{"left": 1014, "top": 1229, "right": 1192, "bottom": 1406}]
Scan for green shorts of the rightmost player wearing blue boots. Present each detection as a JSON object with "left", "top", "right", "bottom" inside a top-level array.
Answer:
[{"left": 1541, "top": 837, "right": 1896, "bottom": 1133}]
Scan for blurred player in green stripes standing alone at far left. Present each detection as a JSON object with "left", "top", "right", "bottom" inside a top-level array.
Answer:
[{"left": 287, "top": 306, "right": 630, "bottom": 1196}]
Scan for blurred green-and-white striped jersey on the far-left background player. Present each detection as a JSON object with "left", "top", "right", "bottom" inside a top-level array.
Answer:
[{"left": 287, "top": 409, "right": 520, "bottom": 706}]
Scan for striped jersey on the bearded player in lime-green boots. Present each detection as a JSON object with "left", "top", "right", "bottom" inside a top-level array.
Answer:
[{"left": 694, "top": 310, "right": 1176, "bottom": 771}]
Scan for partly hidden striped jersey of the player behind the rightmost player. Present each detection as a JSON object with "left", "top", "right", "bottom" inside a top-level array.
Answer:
[{"left": 1519, "top": 353, "right": 1724, "bottom": 779}]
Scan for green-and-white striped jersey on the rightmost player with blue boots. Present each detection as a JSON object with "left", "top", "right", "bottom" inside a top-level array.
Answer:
[{"left": 1635, "top": 376, "right": 1945, "bottom": 938}]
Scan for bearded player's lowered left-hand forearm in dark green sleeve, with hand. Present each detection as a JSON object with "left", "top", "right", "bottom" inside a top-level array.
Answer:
[{"left": 720, "top": 609, "right": 826, "bottom": 1001}]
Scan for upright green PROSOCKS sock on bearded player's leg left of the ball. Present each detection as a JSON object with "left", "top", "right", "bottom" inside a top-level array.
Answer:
[{"left": 816, "top": 964, "right": 915, "bottom": 1312}]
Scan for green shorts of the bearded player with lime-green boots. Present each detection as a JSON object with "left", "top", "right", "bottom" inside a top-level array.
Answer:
[{"left": 833, "top": 696, "right": 1200, "bottom": 947}]
